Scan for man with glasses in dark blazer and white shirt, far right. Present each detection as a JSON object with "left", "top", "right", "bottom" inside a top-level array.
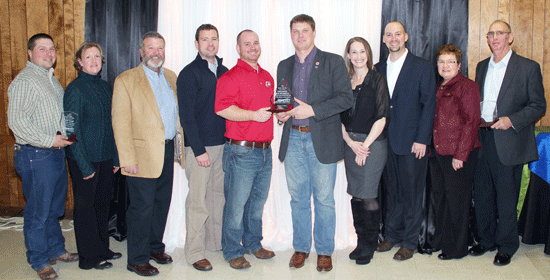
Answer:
[{"left": 469, "top": 20, "right": 546, "bottom": 265}]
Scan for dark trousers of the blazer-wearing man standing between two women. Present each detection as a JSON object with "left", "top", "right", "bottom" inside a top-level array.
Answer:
[{"left": 384, "top": 148, "right": 428, "bottom": 250}]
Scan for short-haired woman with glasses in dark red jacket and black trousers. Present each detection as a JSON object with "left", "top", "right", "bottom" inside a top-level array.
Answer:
[{"left": 433, "top": 45, "right": 481, "bottom": 260}]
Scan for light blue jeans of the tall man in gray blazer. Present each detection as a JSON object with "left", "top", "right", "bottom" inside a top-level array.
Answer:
[{"left": 285, "top": 129, "right": 336, "bottom": 256}]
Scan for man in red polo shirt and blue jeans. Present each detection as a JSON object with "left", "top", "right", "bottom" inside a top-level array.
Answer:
[{"left": 215, "top": 30, "right": 275, "bottom": 269}]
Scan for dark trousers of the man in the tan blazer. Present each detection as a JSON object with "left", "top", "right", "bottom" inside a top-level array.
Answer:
[{"left": 126, "top": 141, "right": 174, "bottom": 265}]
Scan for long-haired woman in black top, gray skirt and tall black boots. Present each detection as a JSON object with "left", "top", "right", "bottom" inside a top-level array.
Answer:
[{"left": 341, "top": 37, "right": 389, "bottom": 264}]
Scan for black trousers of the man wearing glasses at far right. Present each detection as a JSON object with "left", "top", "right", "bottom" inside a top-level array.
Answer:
[{"left": 474, "top": 128, "right": 523, "bottom": 255}]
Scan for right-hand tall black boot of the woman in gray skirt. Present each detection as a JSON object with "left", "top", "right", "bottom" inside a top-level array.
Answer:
[{"left": 355, "top": 208, "right": 380, "bottom": 264}]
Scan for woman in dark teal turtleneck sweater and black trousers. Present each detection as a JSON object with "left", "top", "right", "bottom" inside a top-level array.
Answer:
[{"left": 63, "top": 42, "right": 122, "bottom": 269}]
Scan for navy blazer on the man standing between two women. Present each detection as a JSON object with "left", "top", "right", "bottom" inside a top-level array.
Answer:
[{"left": 375, "top": 51, "right": 437, "bottom": 155}]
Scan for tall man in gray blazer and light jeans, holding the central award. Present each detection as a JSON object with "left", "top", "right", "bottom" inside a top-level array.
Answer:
[{"left": 277, "top": 14, "right": 352, "bottom": 271}]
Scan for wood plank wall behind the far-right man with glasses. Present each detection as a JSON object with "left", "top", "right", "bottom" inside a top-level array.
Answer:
[{"left": 468, "top": 0, "right": 550, "bottom": 126}]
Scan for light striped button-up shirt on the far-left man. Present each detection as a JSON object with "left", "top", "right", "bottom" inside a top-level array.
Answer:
[{"left": 8, "top": 61, "right": 63, "bottom": 148}]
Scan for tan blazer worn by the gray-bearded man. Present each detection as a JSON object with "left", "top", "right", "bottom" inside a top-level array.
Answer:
[{"left": 112, "top": 64, "right": 185, "bottom": 178}]
